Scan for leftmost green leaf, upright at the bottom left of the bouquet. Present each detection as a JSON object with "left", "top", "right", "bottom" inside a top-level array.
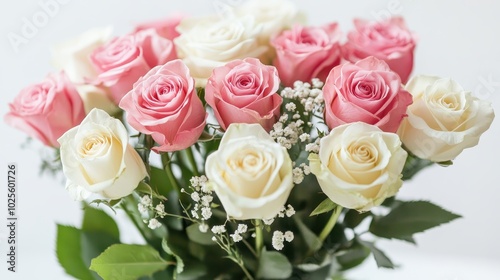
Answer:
[{"left": 56, "top": 224, "right": 94, "bottom": 280}]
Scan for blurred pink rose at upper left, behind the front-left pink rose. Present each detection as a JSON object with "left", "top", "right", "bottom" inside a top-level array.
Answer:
[{"left": 90, "top": 29, "right": 176, "bottom": 104}]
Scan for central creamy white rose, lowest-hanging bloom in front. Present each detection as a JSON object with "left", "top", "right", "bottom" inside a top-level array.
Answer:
[{"left": 205, "top": 124, "right": 293, "bottom": 220}]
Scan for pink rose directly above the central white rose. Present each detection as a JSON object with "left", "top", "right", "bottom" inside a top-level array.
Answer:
[{"left": 205, "top": 58, "right": 282, "bottom": 131}]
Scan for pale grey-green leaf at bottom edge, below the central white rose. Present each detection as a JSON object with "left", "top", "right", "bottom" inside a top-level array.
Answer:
[{"left": 257, "top": 249, "right": 292, "bottom": 279}]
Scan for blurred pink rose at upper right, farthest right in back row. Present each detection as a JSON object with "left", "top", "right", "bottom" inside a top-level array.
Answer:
[{"left": 342, "top": 17, "right": 416, "bottom": 83}]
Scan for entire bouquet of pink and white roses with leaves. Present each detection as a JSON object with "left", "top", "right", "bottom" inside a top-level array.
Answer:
[{"left": 5, "top": 0, "right": 494, "bottom": 279}]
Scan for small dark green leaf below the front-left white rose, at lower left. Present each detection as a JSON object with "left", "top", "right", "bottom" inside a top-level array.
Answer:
[{"left": 82, "top": 205, "right": 120, "bottom": 240}]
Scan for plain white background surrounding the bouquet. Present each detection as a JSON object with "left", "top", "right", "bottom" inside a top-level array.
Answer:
[{"left": 0, "top": 0, "right": 500, "bottom": 280}]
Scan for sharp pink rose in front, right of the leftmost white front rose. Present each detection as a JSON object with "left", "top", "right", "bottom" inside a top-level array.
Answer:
[{"left": 119, "top": 59, "right": 207, "bottom": 152}]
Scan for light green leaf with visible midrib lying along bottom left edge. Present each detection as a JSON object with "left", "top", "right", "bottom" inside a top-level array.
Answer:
[{"left": 90, "top": 244, "right": 172, "bottom": 280}]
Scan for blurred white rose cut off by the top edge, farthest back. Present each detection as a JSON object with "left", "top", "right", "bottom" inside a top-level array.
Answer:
[{"left": 234, "top": 0, "right": 305, "bottom": 44}]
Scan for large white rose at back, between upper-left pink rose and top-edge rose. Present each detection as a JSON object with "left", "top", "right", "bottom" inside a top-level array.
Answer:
[{"left": 174, "top": 17, "right": 268, "bottom": 87}]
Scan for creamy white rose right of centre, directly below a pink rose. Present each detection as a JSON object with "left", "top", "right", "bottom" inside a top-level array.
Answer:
[{"left": 309, "top": 122, "right": 407, "bottom": 211}]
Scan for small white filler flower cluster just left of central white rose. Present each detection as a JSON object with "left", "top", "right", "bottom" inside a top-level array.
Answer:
[{"left": 181, "top": 175, "right": 214, "bottom": 224}]
